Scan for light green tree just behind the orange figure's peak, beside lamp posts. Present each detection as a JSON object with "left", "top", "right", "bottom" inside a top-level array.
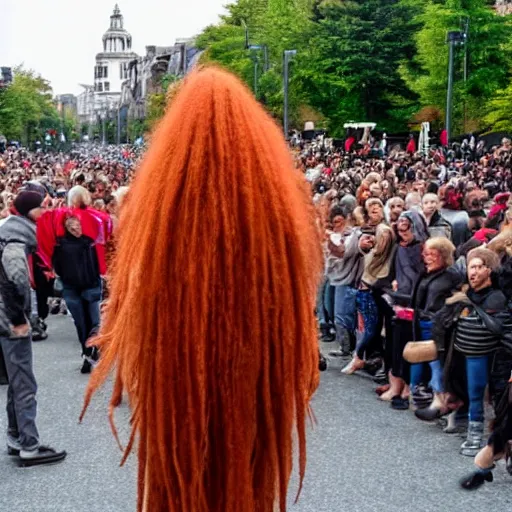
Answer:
[{"left": 197, "top": 0, "right": 313, "bottom": 125}]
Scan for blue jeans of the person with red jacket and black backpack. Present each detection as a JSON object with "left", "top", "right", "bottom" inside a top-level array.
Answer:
[{"left": 62, "top": 284, "right": 101, "bottom": 355}]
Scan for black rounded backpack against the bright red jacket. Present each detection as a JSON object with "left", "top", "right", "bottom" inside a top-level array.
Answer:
[{"left": 53, "top": 235, "right": 100, "bottom": 290}]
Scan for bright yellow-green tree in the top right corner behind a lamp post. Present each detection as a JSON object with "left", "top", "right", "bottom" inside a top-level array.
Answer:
[{"left": 400, "top": 0, "right": 512, "bottom": 132}]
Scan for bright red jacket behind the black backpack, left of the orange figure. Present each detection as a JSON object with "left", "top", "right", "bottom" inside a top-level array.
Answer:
[{"left": 37, "top": 208, "right": 112, "bottom": 275}]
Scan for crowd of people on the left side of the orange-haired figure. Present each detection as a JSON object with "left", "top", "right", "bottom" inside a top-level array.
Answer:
[{"left": 0, "top": 145, "right": 142, "bottom": 466}]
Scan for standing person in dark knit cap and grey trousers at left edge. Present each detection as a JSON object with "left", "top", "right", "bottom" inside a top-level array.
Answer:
[{"left": 0, "top": 190, "right": 66, "bottom": 466}]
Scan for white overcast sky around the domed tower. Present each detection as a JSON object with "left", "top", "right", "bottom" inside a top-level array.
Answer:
[{"left": 0, "top": 0, "right": 230, "bottom": 94}]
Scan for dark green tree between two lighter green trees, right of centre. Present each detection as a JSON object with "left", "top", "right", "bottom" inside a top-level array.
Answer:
[{"left": 302, "top": 0, "right": 420, "bottom": 134}]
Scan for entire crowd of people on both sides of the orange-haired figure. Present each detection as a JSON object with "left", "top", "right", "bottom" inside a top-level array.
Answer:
[{"left": 0, "top": 126, "right": 512, "bottom": 488}]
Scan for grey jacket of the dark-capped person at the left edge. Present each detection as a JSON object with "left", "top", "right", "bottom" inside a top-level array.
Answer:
[{"left": 0, "top": 215, "right": 36, "bottom": 336}]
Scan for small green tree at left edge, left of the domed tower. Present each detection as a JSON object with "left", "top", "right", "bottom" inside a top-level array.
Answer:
[{"left": 0, "top": 66, "right": 65, "bottom": 143}]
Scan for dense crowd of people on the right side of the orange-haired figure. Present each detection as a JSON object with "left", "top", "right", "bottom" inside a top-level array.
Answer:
[{"left": 294, "top": 137, "right": 512, "bottom": 489}]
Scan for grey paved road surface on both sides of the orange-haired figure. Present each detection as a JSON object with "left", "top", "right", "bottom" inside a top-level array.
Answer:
[{"left": 0, "top": 317, "right": 512, "bottom": 512}]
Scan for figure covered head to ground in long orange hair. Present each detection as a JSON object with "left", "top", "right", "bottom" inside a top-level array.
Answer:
[{"left": 81, "top": 68, "right": 321, "bottom": 512}]
